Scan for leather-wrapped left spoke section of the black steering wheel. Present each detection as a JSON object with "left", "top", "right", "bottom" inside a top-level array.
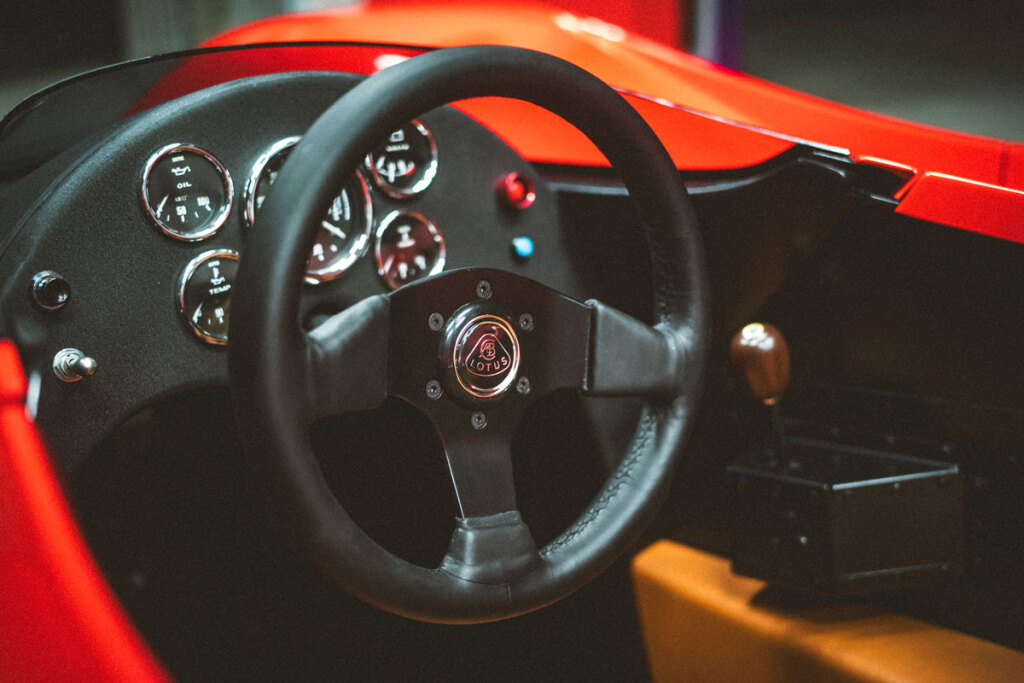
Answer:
[{"left": 306, "top": 295, "right": 389, "bottom": 421}]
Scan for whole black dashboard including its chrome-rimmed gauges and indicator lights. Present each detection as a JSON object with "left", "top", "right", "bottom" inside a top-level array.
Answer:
[{"left": 2, "top": 73, "right": 583, "bottom": 471}]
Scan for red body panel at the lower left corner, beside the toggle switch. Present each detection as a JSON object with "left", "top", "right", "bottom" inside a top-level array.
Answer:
[{"left": 0, "top": 340, "right": 168, "bottom": 681}]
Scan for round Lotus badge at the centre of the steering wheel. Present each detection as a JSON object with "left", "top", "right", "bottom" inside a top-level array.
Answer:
[{"left": 452, "top": 315, "right": 519, "bottom": 398}]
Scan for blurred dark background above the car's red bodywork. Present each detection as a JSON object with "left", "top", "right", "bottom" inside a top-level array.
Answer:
[{"left": 0, "top": 0, "right": 1024, "bottom": 140}]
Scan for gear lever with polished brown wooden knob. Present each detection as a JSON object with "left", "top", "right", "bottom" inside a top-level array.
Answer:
[{"left": 729, "top": 323, "right": 790, "bottom": 455}]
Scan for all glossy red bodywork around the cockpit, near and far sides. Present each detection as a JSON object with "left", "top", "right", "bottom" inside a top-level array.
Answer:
[{"left": 0, "top": 3, "right": 1024, "bottom": 681}]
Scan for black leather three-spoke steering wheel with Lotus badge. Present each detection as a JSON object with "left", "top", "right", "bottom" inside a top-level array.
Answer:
[{"left": 228, "top": 46, "right": 708, "bottom": 624}]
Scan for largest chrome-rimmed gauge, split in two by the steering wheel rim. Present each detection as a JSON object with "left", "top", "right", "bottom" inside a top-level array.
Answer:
[{"left": 245, "top": 137, "right": 373, "bottom": 285}]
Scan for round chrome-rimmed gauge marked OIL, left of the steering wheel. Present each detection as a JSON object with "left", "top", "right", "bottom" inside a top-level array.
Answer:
[{"left": 142, "top": 144, "right": 232, "bottom": 242}]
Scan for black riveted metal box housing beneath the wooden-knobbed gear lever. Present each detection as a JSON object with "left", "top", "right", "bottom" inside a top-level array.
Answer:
[{"left": 728, "top": 437, "right": 964, "bottom": 596}]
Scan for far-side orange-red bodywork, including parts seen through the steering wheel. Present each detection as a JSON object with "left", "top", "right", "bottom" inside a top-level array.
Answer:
[{"left": 201, "top": 2, "right": 1024, "bottom": 243}]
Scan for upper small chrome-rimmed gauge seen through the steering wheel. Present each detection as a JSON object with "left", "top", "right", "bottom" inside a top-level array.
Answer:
[{"left": 367, "top": 120, "right": 437, "bottom": 199}]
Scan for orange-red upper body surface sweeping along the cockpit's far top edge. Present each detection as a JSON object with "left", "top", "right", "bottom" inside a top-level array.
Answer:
[{"left": 207, "top": 3, "right": 1024, "bottom": 189}]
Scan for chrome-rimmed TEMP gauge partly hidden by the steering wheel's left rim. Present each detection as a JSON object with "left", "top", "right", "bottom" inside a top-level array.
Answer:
[{"left": 177, "top": 249, "right": 239, "bottom": 346}]
